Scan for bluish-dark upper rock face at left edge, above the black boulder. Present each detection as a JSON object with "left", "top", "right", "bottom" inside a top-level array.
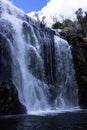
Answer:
[{"left": 0, "top": 34, "right": 12, "bottom": 82}]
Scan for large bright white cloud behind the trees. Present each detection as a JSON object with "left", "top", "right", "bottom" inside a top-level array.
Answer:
[{"left": 27, "top": 0, "right": 87, "bottom": 26}]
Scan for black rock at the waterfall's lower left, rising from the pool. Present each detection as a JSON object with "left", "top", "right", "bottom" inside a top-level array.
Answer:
[{"left": 0, "top": 80, "right": 26, "bottom": 115}]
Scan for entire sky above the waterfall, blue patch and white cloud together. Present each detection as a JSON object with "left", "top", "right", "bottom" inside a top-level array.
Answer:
[{"left": 11, "top": 0, "right": 87, "bottom": 26}]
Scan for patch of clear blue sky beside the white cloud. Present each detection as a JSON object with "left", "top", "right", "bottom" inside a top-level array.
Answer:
[{"left": 11, "top": 0, "right": 47, "bottom": 13}]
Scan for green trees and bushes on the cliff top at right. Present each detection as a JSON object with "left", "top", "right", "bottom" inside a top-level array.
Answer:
[{"left": 52, "top": 8, "right": 87, "bottom": 37}]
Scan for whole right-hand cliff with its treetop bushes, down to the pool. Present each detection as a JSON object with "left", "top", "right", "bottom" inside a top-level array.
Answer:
[{"left": 52, "top": 8, "right": 87, "bottom": 108}]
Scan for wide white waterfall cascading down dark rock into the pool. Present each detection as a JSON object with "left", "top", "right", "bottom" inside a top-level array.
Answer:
[{"left": 0, "top": 0, "right": 78, "bottom": 113}]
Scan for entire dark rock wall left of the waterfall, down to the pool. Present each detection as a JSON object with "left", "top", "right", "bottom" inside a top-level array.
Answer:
[{"left": 0, "top": 33, "right": 26, "bottom": 115}]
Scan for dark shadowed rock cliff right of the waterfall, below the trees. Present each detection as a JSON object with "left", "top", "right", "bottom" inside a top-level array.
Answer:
[{"left": 67, "top": 35, "right": 87, "bottom": 108}]
